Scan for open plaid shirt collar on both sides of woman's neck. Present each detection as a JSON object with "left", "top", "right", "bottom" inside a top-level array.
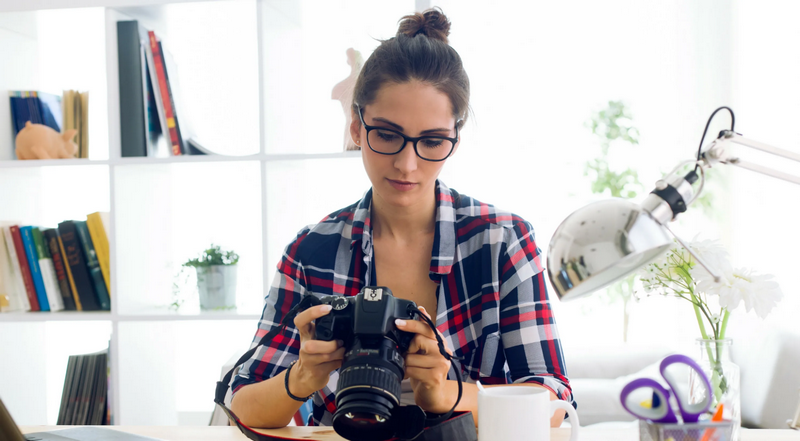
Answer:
[{"left": 350, "top": 179, "right": 456, "bottom": 276}]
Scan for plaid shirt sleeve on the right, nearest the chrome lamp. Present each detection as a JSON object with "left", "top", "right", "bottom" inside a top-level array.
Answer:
[{"left": 500, "top": 221, "right": 576, "bottom": 406}]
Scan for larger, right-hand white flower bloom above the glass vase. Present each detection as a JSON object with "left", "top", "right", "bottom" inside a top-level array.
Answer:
[{"left": 691, "top": 266, "right": 783, "bottom": 319}]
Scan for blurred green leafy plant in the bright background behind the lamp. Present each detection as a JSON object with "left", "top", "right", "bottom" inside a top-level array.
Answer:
[{"left": 584, "top": 101, "right": 644, "bottom": 341}]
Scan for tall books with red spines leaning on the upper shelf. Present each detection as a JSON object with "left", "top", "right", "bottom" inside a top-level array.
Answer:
[{"left": 117, "top": 20, "right": 212, "bottom": 157}]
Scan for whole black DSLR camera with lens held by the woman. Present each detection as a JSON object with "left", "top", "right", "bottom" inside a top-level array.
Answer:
[{"left": 314, "top": 286, "right": 424, "bottom": 441}]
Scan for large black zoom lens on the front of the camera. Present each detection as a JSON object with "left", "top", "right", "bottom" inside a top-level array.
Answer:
[{"left": 333, "top": 337, "right": 404, "bottom": 441}]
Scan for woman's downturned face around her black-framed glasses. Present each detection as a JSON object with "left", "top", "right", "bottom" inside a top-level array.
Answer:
[{"left": 350, "top": 81, "right": 458, "bottom": 211}]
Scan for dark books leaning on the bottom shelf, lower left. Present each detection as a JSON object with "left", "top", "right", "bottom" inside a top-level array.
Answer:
[{"left": 56, "top": 350, "right": 110, "bottom": 426}]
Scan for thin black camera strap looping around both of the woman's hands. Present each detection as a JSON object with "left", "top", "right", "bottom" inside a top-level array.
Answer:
[{"left": 214, "top": 295, "right": 464, "bottom": 441}]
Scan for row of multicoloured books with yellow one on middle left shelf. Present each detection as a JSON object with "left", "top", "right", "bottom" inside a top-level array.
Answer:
[{"left": 0, "top": 212, "right": 111, "bottom": 312}]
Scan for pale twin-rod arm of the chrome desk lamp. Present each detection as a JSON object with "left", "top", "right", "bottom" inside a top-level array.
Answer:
[{"left": 702, "top": 130, "right": 800, "bottom": 185}]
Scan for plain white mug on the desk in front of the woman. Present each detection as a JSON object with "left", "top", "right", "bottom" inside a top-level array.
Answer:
[{"left": 478, "top": 386, "right": 580, "bottom": 441}]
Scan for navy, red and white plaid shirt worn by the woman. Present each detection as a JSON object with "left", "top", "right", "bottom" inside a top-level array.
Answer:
[{"left": 232, "top": 181, "right": 575, "bottom": 425}]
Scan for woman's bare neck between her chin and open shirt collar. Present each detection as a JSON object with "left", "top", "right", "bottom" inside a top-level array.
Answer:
[{"left": 372, "top": 186, "right": 436, "bottom": 242}]
